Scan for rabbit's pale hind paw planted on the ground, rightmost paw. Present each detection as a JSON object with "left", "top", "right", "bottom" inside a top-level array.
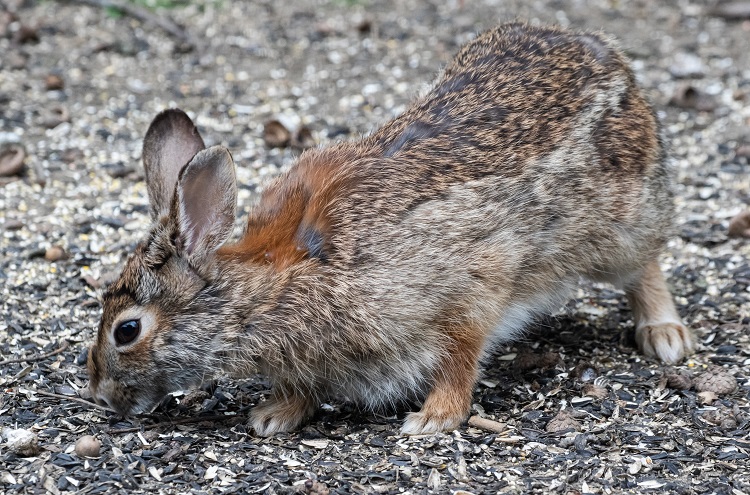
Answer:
[{"left": 635, "top": 322, "right": 694, "bottom": 364}]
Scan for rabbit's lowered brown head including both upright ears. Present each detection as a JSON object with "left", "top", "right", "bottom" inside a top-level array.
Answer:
[{"left": 88, "top": 110, "right": 237, "bottom": 414}]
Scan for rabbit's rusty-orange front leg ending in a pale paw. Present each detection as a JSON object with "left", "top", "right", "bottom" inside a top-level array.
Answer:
[{"left": 401, "top": 327, "right": 484, "bottom": 435}]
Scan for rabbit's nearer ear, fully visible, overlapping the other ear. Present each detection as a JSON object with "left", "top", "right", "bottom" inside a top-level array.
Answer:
[{"left": 171, "top": 146, "right": 237, "bottom": 266}]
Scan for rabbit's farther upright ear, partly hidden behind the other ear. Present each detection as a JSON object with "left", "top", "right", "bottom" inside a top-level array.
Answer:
[{"left": 143, "top": 108, "right": 205, "bottom": 220}]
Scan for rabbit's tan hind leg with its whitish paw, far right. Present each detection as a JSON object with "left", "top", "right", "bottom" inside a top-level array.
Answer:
[{"left": 625, "top": 260, "right": 695, "bottom": 363}]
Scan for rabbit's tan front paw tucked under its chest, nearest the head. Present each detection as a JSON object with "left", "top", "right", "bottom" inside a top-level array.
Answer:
[{"left": 250, "top": 395, "right": 315, "bottom": 437}]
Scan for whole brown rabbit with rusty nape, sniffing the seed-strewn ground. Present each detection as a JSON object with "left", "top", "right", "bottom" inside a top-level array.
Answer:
[{"left": 88, "top": 23, "right": 694, "bottom": 436}]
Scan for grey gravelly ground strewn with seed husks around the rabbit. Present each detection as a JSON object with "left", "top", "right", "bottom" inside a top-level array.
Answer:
[{"left": 0, "top": 0, "right": 750, "bottom": 495}]
